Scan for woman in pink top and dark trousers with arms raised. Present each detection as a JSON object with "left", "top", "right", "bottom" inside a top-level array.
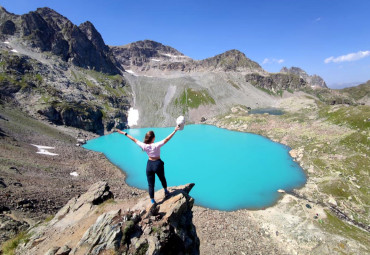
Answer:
[{"left": 117, "top": 126, "right": 180, "bottom": 204}]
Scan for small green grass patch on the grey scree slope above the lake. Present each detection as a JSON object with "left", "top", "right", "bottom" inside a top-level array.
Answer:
[{"left": 175, "top": 88, "right": 216, "bottom": 108}]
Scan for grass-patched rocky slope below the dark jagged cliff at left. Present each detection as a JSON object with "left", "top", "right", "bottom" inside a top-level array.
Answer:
[{"left": 0, "top": 42, "right": 129, "bottom": 134}]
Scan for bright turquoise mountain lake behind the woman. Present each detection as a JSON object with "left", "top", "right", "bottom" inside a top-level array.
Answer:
[{"left": 84, "top": 125, "right": 306, "bottom": 211}]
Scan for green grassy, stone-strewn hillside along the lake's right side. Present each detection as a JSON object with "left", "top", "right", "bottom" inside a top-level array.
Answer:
[{"left": 218, "top": 96, "right": 370, "bottom": 242}]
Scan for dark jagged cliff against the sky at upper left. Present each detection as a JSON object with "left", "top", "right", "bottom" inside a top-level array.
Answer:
[{"left": 0, "top": 5, "right": 120, "bottom": 74}]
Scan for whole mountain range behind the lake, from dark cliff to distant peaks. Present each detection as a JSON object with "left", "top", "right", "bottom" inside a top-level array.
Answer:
[{"left": 0, "top": 7, "right": 366, "bottom": 133}]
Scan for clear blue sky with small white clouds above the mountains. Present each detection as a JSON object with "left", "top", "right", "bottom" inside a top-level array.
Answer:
[{"left": 0, "top": 0, "right": 370, "bottom": 88}]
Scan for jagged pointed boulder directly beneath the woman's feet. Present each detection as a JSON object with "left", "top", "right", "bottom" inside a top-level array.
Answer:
[{"left": 73, "top": 184, "right": 199, "bottom": 254}]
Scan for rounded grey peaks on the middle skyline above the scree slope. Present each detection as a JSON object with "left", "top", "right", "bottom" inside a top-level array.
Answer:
[{"left": 111, "top": 40, "right": 263, "bottom": 72}]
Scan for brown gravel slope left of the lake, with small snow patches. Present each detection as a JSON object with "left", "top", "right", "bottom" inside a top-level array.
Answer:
[{"left": 0, "top": 103, "right": 144, "bottom": 223}]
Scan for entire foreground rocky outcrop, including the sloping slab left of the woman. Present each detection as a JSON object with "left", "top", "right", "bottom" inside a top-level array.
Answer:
[{"left": 17, "top": 182, "right": 199, "bottom": 255}]
